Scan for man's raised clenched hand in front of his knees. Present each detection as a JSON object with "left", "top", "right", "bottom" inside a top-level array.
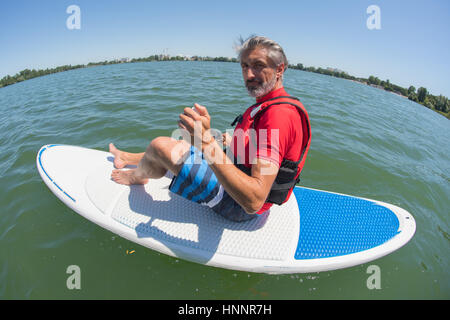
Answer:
[{"left": 178, "top": 103, "right": 214, "bottom": 145}]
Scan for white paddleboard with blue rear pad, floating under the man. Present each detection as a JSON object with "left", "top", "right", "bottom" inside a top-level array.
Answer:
[{"left": 36, "top": 144, "right": 416, "bottom": 274}]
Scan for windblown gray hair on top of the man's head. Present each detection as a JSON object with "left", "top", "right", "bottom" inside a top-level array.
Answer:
[{"left": 235, "top": 36, "right": 288, "bottom": 71}]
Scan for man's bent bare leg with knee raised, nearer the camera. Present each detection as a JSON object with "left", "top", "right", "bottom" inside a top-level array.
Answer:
[{"left": 111, "top": 137, "right": 190, "bottom": 185}]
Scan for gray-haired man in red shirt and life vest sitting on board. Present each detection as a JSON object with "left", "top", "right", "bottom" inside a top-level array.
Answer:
[{"left": 110, "top": 37, "right": 310, "bottom": 221}]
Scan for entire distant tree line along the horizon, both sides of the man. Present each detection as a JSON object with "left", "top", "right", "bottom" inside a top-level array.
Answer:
[{"left": 0, "top": 54, "right": 450, "bottom": 119}]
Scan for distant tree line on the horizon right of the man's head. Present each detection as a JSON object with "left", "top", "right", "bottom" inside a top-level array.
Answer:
[{"left": 289, "top": 63, "right": 450, "bottom": 119}]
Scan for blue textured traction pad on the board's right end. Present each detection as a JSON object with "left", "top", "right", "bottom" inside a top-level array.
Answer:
[{"left": 294, "top": 188, "right": 399, "bottom": 260}]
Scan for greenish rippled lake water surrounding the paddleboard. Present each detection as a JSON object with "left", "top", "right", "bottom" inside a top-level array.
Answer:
[{"left": 0, "top": 62, "right": 450, "bottom": 299}]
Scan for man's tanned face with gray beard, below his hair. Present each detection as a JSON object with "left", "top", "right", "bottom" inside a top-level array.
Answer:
[{"left": 241, "top": 48, "right": 278, "bottom": 98}]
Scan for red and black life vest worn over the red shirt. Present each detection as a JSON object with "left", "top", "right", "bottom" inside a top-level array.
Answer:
[{"left": 231, "top": 96, "right": 311, "bottom": 205}]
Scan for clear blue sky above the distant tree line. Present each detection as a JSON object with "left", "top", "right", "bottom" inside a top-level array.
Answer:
[{"left": 0, "top": 0, "right": 450, "bottom": 97}]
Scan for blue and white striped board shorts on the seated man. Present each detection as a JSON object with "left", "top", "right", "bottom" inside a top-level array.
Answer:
[{"left": 169, "top": 146, "right": 257, "bottom": 221}]
